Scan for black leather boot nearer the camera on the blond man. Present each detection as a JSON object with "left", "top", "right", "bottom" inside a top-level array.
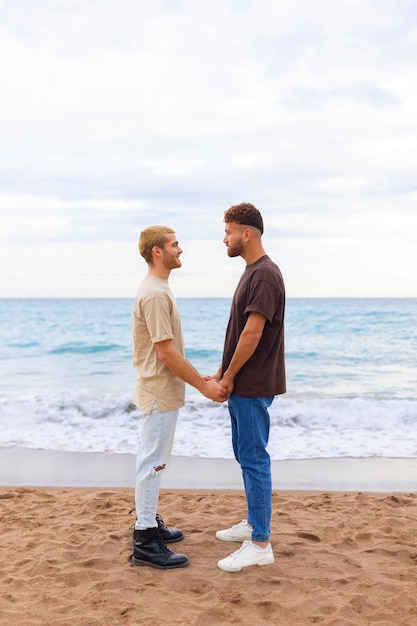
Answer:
[{"left": 132, "top": 527, "right": 189, "bottom": 569}]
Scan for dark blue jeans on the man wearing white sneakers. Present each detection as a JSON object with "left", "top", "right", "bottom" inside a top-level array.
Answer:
[{"left": 229, "top": 393, "right": 274, "bottom": 541}]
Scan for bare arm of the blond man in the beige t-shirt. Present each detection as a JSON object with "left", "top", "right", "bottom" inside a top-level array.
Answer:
[{"left": 155, "top": 339, "right": 227, "bottom": 402}]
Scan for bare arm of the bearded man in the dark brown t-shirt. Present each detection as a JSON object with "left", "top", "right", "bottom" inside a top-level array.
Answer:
[{"left": 220, "top": 313, "right": 266, "bottom": 396}]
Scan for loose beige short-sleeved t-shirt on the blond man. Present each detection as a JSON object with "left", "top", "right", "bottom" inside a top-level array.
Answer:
[{"left": 132, "top": 275, "right": 185, "bottom": 414}]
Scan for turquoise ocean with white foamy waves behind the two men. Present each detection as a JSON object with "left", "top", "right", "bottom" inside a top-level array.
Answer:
[{"left": 0, "top": 298, "right": 417, "bottom": 460}]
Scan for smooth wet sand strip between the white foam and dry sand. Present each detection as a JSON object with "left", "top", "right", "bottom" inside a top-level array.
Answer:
[{"left": 0, "top": 448, "right": 417, "bottom": 492}]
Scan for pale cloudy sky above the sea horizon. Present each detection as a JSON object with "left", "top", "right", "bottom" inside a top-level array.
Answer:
[{"left": 0, "top": 0, "right": 417, "bottom": 298}]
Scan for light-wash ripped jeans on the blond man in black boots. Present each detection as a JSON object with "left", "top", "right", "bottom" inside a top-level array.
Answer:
[{"left": 135, "top": 404, "right": 178, "bottom": 530}]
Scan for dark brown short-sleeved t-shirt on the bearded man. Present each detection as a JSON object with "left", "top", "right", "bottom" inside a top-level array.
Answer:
[{"left": 222, "top": 255, "right": 286, "bottom": 398}]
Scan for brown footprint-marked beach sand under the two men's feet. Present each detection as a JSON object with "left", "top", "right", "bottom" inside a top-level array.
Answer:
[{"left": 0, "top": 451, "right": 417, "bottom": 626}]
